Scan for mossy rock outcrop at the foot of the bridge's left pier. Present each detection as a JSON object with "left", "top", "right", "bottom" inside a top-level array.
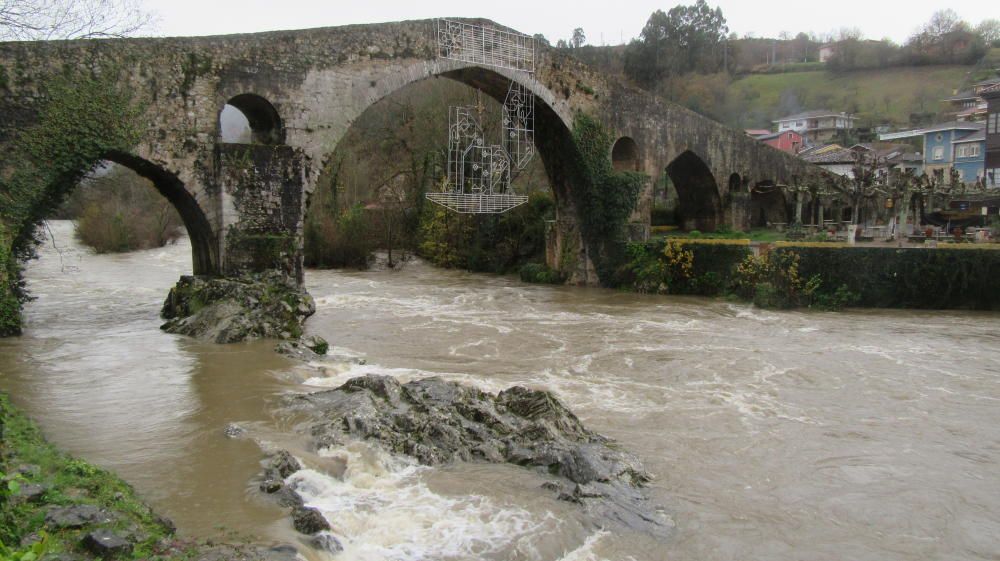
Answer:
[{"left": 161, "top": 273, "right": 316, "bottom": 343}]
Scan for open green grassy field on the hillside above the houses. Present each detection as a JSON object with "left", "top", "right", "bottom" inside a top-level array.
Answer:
[{"left": 728, "top": 65, "right": 976, "bottom": 127}]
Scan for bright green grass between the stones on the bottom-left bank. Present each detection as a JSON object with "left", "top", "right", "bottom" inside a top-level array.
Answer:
[{"left": 0, "top": 395, "right": 197, "bottom": 559}]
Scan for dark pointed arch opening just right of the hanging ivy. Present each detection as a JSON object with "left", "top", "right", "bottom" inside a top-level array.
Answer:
[{"left": 667, "top": 150, "right": 722, "bottom": 231}]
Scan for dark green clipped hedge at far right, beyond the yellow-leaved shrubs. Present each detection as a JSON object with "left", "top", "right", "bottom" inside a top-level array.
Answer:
[{"left": 775, "top": 247, "right": 1000, "bottom": 310}]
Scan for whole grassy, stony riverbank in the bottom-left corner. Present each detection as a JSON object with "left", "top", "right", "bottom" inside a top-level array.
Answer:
[{"left": 0, "top": 394, "right": 295, "bottom": 561}]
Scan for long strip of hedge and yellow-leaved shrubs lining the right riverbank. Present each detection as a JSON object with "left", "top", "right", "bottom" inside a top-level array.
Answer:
[{"left": 614, "top": 239, "right": 1000, "bottom": 310}]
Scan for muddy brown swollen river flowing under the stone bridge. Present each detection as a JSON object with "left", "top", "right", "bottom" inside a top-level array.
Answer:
[{"left": 0, "top": 222, "right": 1000, "bottom": 561}]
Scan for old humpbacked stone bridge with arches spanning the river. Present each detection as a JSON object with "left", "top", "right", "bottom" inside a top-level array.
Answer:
[{"left": 0, "top": 20, "right": 827, "bottom": 283}]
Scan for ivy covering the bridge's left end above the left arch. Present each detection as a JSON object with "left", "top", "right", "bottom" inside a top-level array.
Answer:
[{"left": 0, "top": 67, "right": 143, "bottom": 336}]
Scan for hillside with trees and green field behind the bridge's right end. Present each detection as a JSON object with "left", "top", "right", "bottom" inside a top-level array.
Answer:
[{"left": 569, "top": 0, "right": 1000, "bottom": 129}]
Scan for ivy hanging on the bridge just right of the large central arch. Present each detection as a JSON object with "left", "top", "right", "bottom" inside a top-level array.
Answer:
[{"left": 571, "top": 113, "right": 648, "bottom": 284}]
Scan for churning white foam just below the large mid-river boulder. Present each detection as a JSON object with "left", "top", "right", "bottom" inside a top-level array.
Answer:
[{"left": 286, "top": 442, "right": 561, "bottom": 561}]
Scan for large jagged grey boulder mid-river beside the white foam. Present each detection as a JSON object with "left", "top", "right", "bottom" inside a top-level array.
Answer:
[{"left": 296, "top": 375, "right": 669, "bottom": 537}]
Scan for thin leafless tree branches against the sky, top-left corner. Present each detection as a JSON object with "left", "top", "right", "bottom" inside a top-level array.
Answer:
[{"left": 0, "top": 0, "right": 153, "bottom": 41}]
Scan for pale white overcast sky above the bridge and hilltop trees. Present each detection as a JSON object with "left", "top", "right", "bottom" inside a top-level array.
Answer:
[{"left": 141, "top": 0, "right": 1000, "bottom": 45}]
